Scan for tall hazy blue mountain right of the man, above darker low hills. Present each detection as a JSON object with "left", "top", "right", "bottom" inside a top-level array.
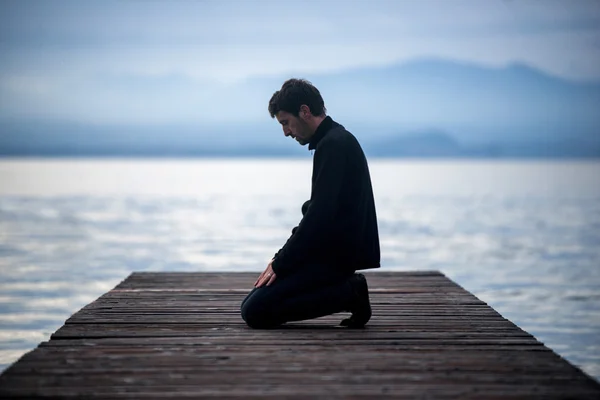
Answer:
[{"left": 314, "top": 60, "right": 600, "bottom": 142}]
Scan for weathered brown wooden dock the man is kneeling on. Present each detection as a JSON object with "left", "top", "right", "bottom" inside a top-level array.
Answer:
[{"left": 0, "top": 272, "right": 600, "bottom": 399}]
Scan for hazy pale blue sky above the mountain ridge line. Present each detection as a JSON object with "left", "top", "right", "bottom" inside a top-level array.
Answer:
[{"left": 0, "top": 0, "right": 600, "bottom": 122}]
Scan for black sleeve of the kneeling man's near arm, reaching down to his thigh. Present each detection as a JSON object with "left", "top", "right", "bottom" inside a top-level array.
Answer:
[{"left": 273, "top": 141, "right": 347, "bottom": 276}]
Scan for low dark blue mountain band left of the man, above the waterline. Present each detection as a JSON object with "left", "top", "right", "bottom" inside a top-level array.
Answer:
[{"left": 0, "top": 120, "right": 307, "bottom": 157}]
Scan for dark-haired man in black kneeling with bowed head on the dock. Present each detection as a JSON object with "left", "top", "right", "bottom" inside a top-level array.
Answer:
[{"left": 241, "top": 79, "right": 380, "bottom": 328}]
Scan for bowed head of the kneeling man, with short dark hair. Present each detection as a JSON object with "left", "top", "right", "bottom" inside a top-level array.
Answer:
[{"left": 269, "top": 79, "right": 327, "bottom": 146}]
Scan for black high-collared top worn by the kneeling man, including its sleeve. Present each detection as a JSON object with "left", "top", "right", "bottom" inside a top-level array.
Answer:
[{"left": 273, "top": 117, "right": 380, "bottom": 276}]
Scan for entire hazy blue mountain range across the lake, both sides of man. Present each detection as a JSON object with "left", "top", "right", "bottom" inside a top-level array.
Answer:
[{"left": 0, "top": 60, "right": 600, "bottom": 157}]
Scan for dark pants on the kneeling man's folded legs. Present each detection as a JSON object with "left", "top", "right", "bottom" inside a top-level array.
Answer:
[{"left": 241, "top": 264, "right": 353, "bottom": 328}]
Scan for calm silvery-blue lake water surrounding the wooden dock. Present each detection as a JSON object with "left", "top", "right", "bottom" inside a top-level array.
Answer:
[{"left": 0, "top": 157, "right": 600, "bottom": 378}]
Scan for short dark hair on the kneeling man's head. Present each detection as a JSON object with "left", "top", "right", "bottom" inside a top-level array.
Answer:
[{"left": 269, "top": 79, "right": 327, "bottom": 118}]
